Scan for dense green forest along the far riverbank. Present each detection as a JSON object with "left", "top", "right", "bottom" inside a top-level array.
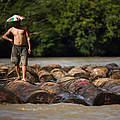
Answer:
[{"left": 0, "top": 0, "right": 120, "bottom": 57}]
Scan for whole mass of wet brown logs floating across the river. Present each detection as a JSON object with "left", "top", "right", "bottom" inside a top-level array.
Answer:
[{"left": 0, "top": 63, "right": 120, "bottom": 106}]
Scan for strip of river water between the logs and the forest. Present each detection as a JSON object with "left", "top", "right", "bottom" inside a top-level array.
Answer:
[{"left": 0, "top": 57, "right": 120, "bottom": 66}]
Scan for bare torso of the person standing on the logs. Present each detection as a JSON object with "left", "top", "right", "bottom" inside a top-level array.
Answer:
[{"left": 11, "top": 27, "right": 26, "bottom": 45}]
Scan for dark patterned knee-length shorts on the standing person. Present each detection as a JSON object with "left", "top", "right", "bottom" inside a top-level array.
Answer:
[{"left": 11, "top": 45, "right": 28, "bottom": 65}]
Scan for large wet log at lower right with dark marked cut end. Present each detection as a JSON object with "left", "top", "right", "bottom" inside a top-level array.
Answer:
[{"left": 57, "top": 79, "right": 120, "bottom": 105}]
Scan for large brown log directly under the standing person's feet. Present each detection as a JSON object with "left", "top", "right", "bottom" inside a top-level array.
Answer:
[{"left": 4, "top": 81, "right": 56, "bottom": 104}]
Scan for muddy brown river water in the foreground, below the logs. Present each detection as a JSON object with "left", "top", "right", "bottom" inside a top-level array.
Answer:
[{"left": 0, "top": 103, "right": 120, "bottom": 120}]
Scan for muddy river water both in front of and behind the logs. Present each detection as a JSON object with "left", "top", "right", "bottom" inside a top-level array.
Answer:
[{"left": 0, "top": 57, "right": 120, "bottom": 120}]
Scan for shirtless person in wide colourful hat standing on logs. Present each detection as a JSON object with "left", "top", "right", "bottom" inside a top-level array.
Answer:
[{"left": 2, "top": 15, "right": 31, "bottom": 81}]
